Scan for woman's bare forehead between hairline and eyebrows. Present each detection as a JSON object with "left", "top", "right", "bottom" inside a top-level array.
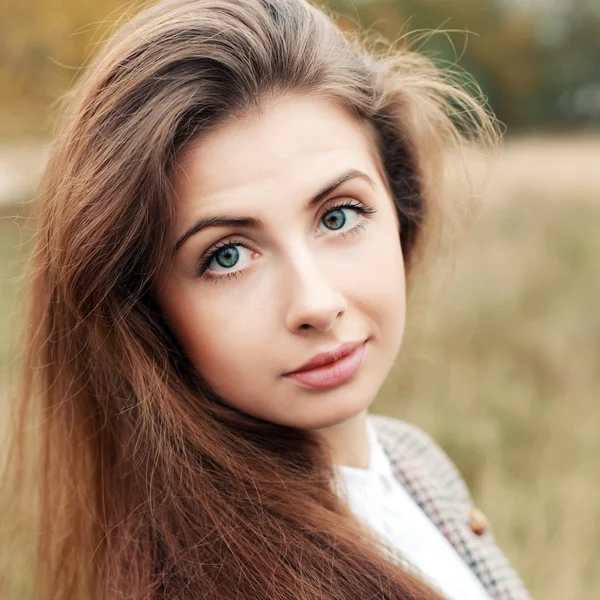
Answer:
[{"left": 174, "top": 97, "right": 376, "bottom": 210}]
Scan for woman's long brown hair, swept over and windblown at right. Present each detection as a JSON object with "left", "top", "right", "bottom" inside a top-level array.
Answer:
[{"left": 4, "top": 0, "right": 496, "bottom": 600}]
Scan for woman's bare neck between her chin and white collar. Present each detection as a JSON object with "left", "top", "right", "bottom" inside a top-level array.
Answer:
[{"left": 315, "top": 409, "right": 370, "bottom": 469}]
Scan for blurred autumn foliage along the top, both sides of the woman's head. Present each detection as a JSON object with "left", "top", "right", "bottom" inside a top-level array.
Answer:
[{"left": 0, "top": 0, "right": 600, "bottom": 137}]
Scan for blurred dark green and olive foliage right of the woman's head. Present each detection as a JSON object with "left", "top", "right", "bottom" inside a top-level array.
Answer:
[{"left": 320, "top": 0, "right": 600, "bottom": 134}]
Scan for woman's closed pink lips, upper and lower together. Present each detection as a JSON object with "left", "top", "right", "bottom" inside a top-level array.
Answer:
[{"left": 286, "top": 341, "right": 367, "bottom": 389}]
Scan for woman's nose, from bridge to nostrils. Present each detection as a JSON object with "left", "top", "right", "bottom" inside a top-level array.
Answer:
[{"left": 284, "top": 246, "right": 347, "bottom": 333}]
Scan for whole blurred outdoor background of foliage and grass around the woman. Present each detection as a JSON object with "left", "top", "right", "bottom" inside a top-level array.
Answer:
[{"left": 0, "top": 0, "right": 600, "bottom": 600}]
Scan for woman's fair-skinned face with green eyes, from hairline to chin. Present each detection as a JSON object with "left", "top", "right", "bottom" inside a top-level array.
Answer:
[{"left": 157, "top": 96, "right": 405, "bottom": 429}]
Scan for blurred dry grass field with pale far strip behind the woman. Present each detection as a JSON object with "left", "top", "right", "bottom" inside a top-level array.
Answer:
[{"left": 0, "top": 137, "right": 600, "bottom": 600}]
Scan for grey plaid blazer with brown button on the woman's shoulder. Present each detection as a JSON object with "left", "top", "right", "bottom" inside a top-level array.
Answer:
[{"left": 369, "top": 415, "right": 531, "bottom": 600}]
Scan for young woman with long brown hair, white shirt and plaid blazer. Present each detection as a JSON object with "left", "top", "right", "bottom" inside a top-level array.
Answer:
[{"left": 2, "top": 0, "right": 528, "bottom": 600}]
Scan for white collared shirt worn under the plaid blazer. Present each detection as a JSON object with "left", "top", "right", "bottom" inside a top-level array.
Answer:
[{"left": 335, "top": 419, "right": 490, "bottom": 600}]
